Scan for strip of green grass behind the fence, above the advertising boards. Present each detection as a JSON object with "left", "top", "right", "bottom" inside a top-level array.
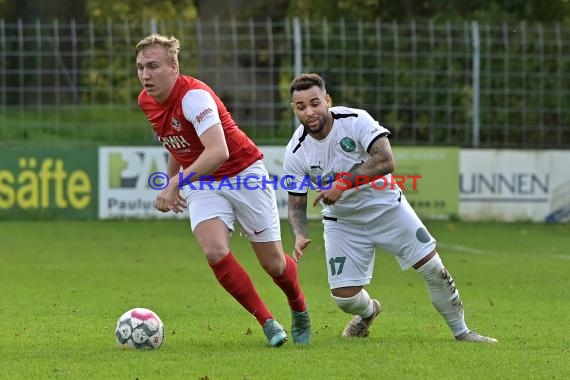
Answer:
[{"left": 0, "top": 104, "right": 290, "bottom": 148}]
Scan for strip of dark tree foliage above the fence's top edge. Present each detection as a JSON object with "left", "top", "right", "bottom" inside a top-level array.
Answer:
[{"left": 0, "top": 0, "right": 570, "bottom": 23}]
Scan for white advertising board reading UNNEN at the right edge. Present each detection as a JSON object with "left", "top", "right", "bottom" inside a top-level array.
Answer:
[{"left": 459, "top": 149, "right": 570, "bottom": 222}]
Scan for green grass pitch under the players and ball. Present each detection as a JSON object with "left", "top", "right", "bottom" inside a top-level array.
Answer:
[{"left": 0, "top": 220, "right": 570, "bottom": 380}]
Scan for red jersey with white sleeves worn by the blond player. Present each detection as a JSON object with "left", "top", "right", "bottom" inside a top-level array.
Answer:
[{"left": 138, "top": 75, "right": 263, "bottom": 180}]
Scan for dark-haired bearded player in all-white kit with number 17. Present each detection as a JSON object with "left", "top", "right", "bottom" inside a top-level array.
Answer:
[{"left": 283, "top": 74, "right": 497, "bottom": 343}]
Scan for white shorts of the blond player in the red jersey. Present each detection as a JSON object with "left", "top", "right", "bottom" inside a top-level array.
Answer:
[{"left": 184, "top": 161, "right": 281, "bottom": 242}]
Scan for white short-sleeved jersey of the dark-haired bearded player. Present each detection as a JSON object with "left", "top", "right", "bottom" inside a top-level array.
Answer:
[{"left": 283, "top": 106, "right": 402, "bottom": 223}]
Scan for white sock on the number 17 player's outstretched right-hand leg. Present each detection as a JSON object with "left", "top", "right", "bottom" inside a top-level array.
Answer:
[{"left": 418, "top": 254, "right": 468, "bottom": 336}]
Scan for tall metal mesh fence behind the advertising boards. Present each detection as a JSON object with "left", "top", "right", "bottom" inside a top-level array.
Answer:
[{"left": 0, "top": 19, "right": 570, "bottom": 148}]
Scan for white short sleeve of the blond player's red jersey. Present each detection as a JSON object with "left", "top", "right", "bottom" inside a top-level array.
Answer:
[{"left": 182, "top": 89, "right": 221, "bottom": 136}]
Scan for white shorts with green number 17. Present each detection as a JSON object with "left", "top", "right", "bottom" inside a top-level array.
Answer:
[{"left": 323, "top": 195, "right": 435, "bottom": 289}]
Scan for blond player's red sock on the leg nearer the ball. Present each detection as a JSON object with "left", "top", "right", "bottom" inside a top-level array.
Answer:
[{"left": 210, "top": 252, "right": 270, "bottom": 326}]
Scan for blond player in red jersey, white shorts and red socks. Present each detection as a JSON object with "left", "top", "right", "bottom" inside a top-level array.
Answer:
[{"left": 135, "top": 34, "right": 311, "bottom": 347}]
